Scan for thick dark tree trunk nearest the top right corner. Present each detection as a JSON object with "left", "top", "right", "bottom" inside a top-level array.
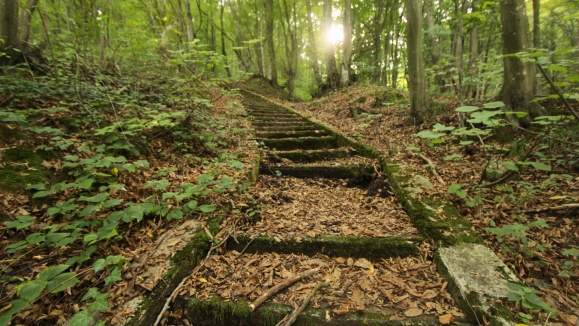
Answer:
[{"left": 498, "top": 0, "right": 542, "bottom": 127}]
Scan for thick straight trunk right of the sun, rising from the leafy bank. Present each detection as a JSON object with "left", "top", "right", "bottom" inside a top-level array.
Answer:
[{"left": 405, "top": 0, "right": 430, "bottom": 125}]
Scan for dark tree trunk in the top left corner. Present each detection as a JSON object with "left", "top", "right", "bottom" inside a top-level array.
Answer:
[{"left": 0, "top": 0, "right": 18, "bottom": 65}]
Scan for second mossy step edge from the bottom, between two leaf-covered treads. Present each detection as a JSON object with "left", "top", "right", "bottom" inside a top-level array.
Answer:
[{"left": 227, "top": 235, "right": 424, "bottom": 260}]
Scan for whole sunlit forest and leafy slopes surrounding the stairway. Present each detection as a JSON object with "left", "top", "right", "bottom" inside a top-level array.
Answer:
[{"left": 0, "top": 0, "right": 579, "bottom": 325}]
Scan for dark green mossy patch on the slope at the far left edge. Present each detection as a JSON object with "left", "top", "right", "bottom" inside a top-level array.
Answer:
[{"left": 0, "top": 147, "right": 52, "bottom": 191}]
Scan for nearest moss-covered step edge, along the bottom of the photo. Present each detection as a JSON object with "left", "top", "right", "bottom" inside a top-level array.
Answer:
[{"left": 173, "top": 296, "right": 470, "bottom": 326}]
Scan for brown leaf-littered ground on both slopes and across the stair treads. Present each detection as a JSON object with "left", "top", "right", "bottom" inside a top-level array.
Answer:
[{"left": 0, "top": 74, "right": 579, "bottom": 325}]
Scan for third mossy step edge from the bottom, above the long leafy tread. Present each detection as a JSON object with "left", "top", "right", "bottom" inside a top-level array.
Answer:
[{"left": 259, "top": 164, "right": 374, "bottom": 179}]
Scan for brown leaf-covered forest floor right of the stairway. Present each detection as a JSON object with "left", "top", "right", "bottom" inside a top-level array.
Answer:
[{"left": 241, "top": 79, "right": 579, "bottom": 325}]
